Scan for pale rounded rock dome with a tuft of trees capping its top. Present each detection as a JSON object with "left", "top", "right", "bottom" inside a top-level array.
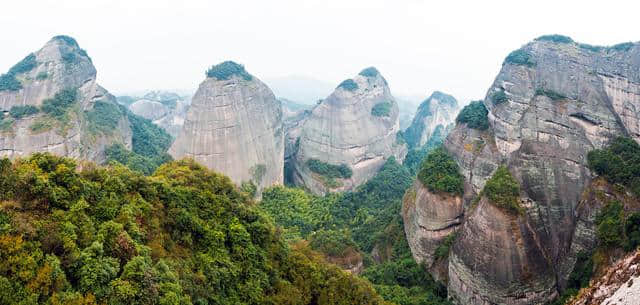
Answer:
[{"left": 169, "top": 62, "right": 284, "bottom": 190}]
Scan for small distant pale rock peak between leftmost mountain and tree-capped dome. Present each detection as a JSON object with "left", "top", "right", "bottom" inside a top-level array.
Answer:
[{"left": 128, "top": 91, "right": 189, "bottom": 138}]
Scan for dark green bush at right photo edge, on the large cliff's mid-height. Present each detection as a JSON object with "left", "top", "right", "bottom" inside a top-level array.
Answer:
[{"left": 587, "top": 137, "right": 640, "bottom": 196}]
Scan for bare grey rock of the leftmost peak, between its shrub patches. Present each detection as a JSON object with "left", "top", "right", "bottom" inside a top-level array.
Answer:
[{"left": 0, "top": 36, "right": 131, "bottom": 162}]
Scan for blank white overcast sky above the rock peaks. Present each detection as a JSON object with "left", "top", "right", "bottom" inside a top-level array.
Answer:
[{"left": 0, "top": 0, "right": 640, "bottom": 101}]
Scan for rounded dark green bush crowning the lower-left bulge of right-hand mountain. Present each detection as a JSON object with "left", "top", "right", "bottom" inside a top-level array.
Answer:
[{"left": 418, "top": 147, "right": 463, "bottom": 195}]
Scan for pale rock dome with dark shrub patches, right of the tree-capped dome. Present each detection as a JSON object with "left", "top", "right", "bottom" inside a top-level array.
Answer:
[{"left": 293, "top": 68, "right": 406, "bottom": 193}]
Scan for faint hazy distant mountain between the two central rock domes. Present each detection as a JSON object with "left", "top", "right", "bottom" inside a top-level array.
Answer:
[{"left": 265, "top": 75, "right": 335, "bottom": 105}]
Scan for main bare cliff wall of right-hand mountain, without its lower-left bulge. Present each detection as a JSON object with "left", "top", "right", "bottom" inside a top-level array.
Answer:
[{"left": 410, "top": 36, "right": 640, "bottom": 304}]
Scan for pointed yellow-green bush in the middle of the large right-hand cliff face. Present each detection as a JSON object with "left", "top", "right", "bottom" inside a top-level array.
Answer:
[{"left": 482, "top": 165, "right": 522, "bottom": 214}]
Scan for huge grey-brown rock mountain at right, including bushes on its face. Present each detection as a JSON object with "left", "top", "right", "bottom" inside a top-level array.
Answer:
[{"left": 403, "top": 35, "right": 640, "bottom": 304}]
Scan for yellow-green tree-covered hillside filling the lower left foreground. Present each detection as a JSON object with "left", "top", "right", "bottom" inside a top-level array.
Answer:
[{"left": 0, "top": 154, "right": 384, "bottom": 305}]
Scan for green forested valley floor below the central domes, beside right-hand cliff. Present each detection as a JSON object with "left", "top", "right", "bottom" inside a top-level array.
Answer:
[{"left": 259, "top": 158, "right": 449, "bottom": 305}]
